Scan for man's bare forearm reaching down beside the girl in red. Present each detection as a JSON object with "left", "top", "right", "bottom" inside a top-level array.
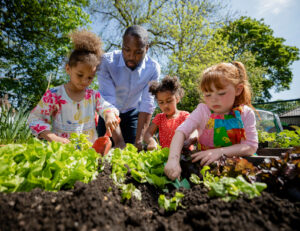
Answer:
[{"left": 135, "top": 112, "right": 152, "bottom": 151}]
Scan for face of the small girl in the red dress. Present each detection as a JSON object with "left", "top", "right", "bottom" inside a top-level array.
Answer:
[{"left": 156, "top": 91, "right": 179, "bottom": 117}]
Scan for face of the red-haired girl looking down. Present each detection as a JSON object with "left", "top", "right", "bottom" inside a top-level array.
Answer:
[{"left": 203, "top": 81, "right": 243, "bottom": 114}]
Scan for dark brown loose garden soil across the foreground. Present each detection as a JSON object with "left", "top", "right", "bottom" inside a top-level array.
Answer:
[{"left": 0, "top": 161, "right": 300, "bottom": 231}]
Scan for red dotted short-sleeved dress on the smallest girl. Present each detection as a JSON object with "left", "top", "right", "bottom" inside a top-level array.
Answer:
[{"left": 152, "top": 111, "right": 190, "bottom": 148}]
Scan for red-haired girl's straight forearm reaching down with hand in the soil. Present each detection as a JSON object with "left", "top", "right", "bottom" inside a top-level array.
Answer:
[{"left": 164, "top": 131, "right": 185, "bottom": 180}]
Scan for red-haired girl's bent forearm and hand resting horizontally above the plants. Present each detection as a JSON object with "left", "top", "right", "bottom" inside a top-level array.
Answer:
[{"left": 191, "top": 144, "right": 256, "bottom": 166}]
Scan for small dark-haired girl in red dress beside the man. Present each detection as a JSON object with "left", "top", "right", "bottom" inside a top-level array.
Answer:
[{"left": 144, "top": 76, "right": 196, "bottom": 150}]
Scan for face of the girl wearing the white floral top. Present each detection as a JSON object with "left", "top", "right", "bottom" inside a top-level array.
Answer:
[{"left": 66, "top": 62, "right": 96, "bottom": 91}]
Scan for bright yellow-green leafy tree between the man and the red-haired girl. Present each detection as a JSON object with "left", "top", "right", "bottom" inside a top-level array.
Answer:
[{"left": 154, "top": 1, "right": 230, "bottom": 111}]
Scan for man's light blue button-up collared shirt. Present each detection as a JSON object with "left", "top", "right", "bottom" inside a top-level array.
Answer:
[{"left": 97, "top": 51, "right": 160, "bottom": 114}]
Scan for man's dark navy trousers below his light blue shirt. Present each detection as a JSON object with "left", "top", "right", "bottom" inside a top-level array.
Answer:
[{"left": 97, "top": 109, "right": 139, "bottom": 144}]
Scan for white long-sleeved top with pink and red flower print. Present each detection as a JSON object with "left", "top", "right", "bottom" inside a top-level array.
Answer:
[{"left": 28, "top": 85, "right": 118, "bottom": 142}]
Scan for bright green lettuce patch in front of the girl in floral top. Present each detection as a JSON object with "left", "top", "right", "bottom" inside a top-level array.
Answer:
[{"left": 0, "top": 134, "right": 100, "bottom": 192}]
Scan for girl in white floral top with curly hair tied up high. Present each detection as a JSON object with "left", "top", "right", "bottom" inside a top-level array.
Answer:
[{"left": 28, "top": 30, "right": 118, "bottom": 143}]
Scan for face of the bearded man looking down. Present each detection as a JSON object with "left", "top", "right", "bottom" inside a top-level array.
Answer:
[{"left": 122, "top": 35, "right": 148, "bottom": 70}]
